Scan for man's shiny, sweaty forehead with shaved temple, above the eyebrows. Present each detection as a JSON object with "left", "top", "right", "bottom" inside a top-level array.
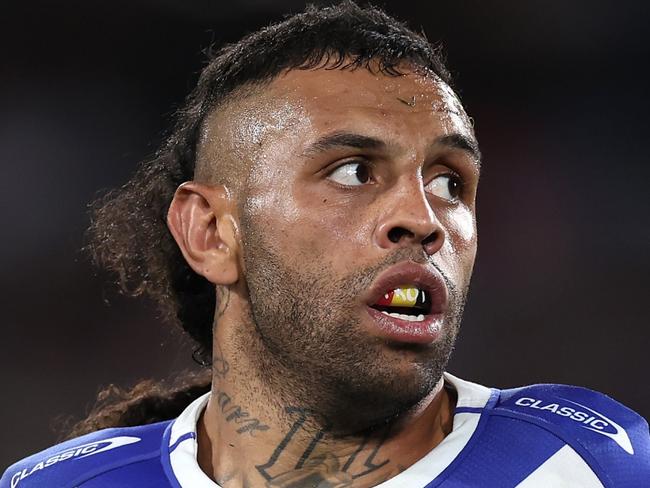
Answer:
[{"left": 199, "top": 68, "right": 474, "bottom": 183}]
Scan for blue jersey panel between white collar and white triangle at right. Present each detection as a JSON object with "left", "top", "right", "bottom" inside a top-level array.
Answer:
[{"left": 426, "top": 410, "right": 565, "bottom": 488}]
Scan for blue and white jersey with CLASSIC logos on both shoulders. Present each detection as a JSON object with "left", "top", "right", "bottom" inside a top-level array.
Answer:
[{"left": 0, "top": 374, "right": 650, "bottom": 488}]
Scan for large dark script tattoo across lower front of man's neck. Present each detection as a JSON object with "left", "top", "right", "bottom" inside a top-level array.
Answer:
[{"left": 255, "top": 407, "right": 395, "bottom": 488}]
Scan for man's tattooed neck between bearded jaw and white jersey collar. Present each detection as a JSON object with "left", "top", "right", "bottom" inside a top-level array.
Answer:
[{"left": 197, "top": 325, "right": 455, "bottom": 488}]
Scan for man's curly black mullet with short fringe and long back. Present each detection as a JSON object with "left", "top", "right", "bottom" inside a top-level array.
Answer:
[{"left": 74, "top": 1, "right": 451, "bottom": 433}]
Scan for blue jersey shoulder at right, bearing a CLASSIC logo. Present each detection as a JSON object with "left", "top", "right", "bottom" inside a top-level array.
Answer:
[{"left": 491, "top": 384, "right": 650, "bottom": 486}]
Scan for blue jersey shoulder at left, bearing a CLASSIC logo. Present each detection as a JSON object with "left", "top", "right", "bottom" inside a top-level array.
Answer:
[{"left": 0, "top": 421, "right": 170, "bottom": 488}]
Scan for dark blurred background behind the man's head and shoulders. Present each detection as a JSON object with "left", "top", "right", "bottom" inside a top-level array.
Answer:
[{"left": 0, "top": 0, "right": 650, "bottom": 471}]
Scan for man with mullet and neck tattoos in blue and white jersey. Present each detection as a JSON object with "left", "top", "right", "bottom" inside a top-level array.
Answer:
[{"left": 0, "top": 3, "right": 650, "bottom": 488}]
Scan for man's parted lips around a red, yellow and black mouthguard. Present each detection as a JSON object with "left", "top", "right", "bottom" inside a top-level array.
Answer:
[{"left": 364, "top": 262, "right": 448, "bottom": 343}]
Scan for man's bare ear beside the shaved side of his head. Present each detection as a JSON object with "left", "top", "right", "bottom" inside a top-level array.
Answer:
[{"left": 167, "top": 181, "right": 240, "bottom": 285}]
